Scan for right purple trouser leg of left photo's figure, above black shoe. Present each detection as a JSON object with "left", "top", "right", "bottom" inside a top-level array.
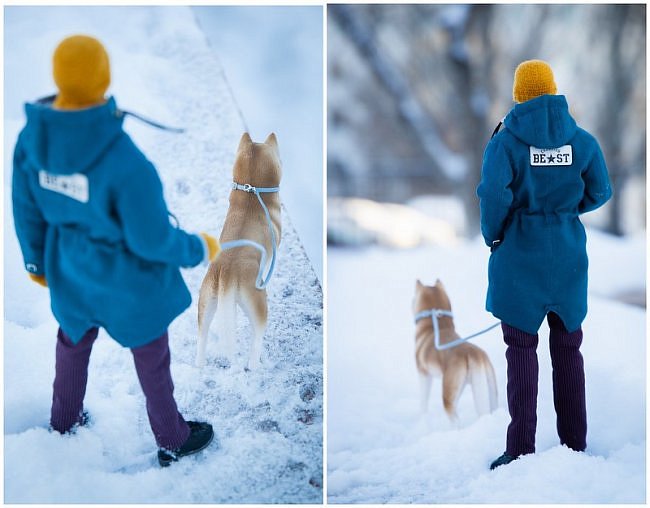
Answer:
[{"left": 131, "top": 332, "right": 190, "bottom": 450}]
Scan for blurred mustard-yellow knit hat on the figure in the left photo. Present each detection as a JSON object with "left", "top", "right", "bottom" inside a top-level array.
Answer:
[{"left": 52, "top": 35, "right": 111, "bottom": 109}]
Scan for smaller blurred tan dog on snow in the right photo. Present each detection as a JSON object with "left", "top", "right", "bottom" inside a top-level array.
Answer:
[{"left": 413, "top": 280, "right": 497, "bottom": 423}]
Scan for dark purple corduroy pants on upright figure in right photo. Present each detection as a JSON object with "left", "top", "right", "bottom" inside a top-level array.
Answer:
[{"left": 501, "top": 313, "right": 587, "bottom": 457}]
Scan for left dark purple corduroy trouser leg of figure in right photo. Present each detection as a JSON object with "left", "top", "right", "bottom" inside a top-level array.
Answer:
[{"left": 501, "top": 323, "right": 539, "bottom": 457}]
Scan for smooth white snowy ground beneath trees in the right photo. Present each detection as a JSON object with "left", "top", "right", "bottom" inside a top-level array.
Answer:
[{"left": 327, "top": 231, "right": 646, "bottom": 504}]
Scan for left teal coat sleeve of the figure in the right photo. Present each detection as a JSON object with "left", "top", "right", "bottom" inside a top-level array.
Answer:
[{"left": 476, "top": 137, "right": 513, "bottom": 246}]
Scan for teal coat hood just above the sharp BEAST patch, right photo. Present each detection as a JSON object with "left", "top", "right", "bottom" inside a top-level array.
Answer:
[{"left": 503, "top": 95, "right": 577, "bottom": 148}]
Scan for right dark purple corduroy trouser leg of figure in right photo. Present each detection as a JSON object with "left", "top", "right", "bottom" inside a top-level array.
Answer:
[{"left": 547, "top": 313, "right": 587, "bottom": 452}]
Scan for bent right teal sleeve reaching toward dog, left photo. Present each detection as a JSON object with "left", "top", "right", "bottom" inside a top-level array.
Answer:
[{"left": 115, "top": 156, "right": 205, "bottom": 267}]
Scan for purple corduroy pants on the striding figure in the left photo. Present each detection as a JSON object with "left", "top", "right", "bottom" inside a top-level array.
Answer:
[{"left": 50, "top": 328, "right": 190, "bottom": 450}]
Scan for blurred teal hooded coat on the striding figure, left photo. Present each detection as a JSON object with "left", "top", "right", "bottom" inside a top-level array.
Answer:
[{"left": 12, "top": 98, "right": 204, "bottom": 347}]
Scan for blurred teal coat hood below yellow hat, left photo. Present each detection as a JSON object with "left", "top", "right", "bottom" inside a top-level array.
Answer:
[{"left": 20, "top": 97, "right": 123, "bottom": 175}]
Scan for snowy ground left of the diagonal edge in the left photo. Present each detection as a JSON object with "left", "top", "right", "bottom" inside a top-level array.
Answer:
[{"left": 4, "top": 7, "right": 323, "bottom": 504}]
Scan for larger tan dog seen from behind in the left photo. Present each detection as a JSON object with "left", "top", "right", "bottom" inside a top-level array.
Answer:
[{"left": 196, "top": 133, "right": 282, "bottom": 369}]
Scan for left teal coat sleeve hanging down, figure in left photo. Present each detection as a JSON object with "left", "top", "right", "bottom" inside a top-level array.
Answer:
[{"left": 11, "top": 138, "right": 47, "bottom": 275}]
